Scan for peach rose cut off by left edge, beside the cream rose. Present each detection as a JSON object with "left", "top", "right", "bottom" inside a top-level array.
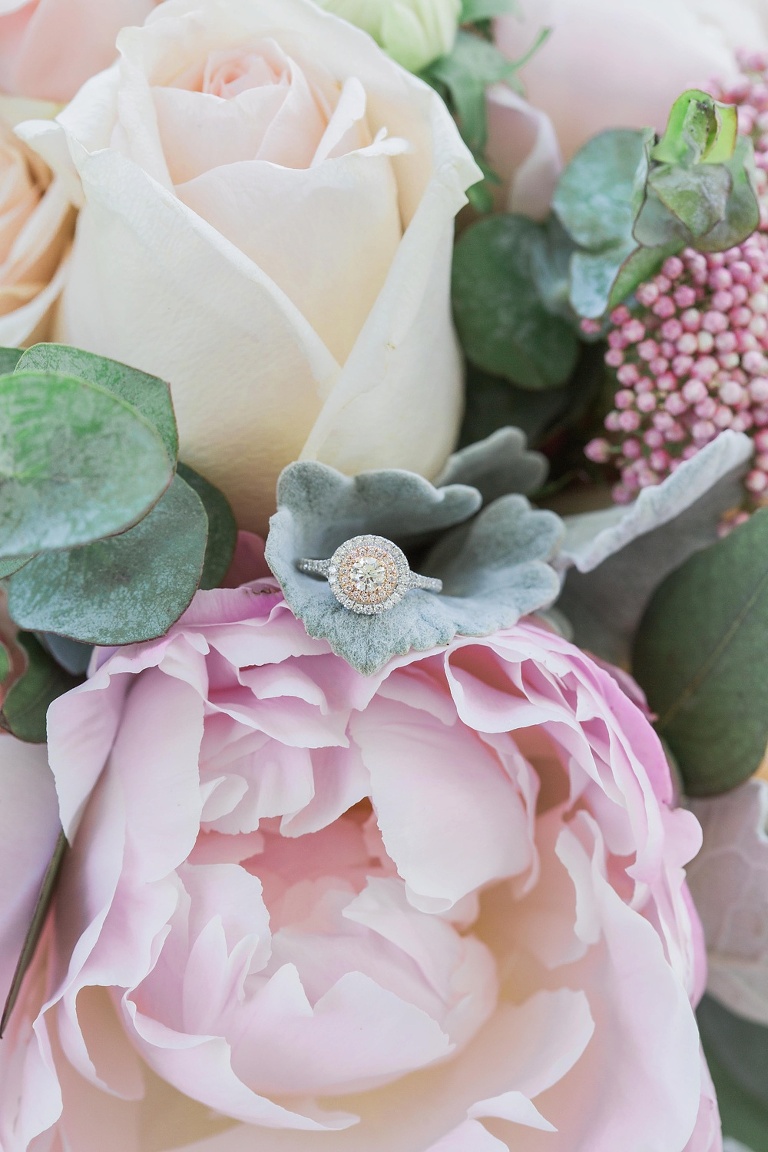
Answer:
[{"left": 0, "top": 97, "right": 75, "bottom": 348}]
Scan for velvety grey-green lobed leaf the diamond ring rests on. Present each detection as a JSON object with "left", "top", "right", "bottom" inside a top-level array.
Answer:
[{"left": 266, "top": 462, "right": 562, "bottom": 674}]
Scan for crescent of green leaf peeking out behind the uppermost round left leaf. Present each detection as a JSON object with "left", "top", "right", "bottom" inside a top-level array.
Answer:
[{"left": 16, "top": 344, "right": 178, "bottom": 463}]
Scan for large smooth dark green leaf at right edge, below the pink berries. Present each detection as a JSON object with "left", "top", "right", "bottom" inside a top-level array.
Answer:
[{"left": 633, "top": 509, "right": 768, "bottom": 796}]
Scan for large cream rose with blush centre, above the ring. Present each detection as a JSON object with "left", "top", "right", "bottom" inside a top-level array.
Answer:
[{"left": 21, "top": 0, "right": 480, "bottom": 528}]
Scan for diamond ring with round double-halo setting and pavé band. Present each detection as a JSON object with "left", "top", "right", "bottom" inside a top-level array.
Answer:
[{"left": 296, "top": 536, "right": 442, "bottom": 616}]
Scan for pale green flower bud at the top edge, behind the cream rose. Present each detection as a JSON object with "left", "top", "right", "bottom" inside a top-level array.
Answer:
[{"left": 317, "top": 0, "right": 462, "bottom": 71}]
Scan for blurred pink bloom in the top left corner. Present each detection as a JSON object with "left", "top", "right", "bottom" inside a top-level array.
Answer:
[{"left": 0, "top": 0, "right": 158, "bottom": 103}]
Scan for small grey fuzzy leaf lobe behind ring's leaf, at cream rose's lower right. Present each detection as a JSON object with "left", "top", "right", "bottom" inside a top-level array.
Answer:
[{"left": 435, "top": 427, "right": 549, "bottom": 503}]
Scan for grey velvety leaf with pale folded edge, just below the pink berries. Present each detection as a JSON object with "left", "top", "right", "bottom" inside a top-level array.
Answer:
[{"left": 556, "top": 431, "right": 753, "bottom": 667}]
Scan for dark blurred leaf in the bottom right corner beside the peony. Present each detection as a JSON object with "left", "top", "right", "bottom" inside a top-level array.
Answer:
[{"left": 697, "top": 996, "right": 768, "bottom": 1152}]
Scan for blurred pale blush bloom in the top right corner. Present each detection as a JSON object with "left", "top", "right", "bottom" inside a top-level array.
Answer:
[{"left": 495, "top": 0, "right": 768, "bottom": 160}]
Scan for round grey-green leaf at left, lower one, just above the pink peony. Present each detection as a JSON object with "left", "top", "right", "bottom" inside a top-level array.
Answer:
[{"left": 8, "top": 476, "right": 207, "bottom": 645}]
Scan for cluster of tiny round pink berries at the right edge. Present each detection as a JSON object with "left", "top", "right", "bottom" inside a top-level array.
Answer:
[{"left": 583, "top": 54, "right": 768, "bottom": 507}]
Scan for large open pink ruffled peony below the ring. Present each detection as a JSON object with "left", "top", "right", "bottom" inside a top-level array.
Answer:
[{"left": 0, "top": 582, "right": 721, "bottom": 1152}]
